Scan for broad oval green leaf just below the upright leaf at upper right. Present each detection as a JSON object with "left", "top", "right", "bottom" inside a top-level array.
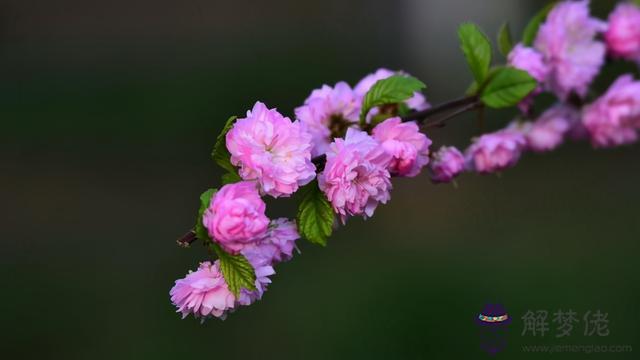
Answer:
[{"left": 480, "top": 67, "right": 537, "bottom": 109}]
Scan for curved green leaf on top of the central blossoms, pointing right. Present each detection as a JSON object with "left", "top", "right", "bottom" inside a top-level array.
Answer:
[{"left": 360, "top": 75, "right": 426, "bottom": 125}]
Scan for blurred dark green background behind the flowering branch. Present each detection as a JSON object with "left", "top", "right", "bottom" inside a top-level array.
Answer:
[{"left": 0, "top": 0, "right": 640, "bottom": 359}]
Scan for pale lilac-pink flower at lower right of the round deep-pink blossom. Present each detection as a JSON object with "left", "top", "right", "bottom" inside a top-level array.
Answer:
[{"left": 242, "top": 218, "right": 300, "bottom": 265}]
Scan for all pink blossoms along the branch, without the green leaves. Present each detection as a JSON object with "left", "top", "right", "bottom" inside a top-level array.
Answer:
[{"left": 170, "top": 0, "right": 640, "bottom": 319}]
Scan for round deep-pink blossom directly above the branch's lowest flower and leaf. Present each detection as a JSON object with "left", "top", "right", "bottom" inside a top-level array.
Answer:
[{"left": 202, "top": 181, "right": 269, "bottom": 254}]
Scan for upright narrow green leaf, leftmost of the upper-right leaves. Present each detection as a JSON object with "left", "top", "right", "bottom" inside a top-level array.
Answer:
[{"left": 458, "top": 23, "right": 491, "bottom": 84}]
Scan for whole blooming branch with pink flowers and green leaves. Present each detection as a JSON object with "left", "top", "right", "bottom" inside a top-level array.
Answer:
[{"left": 170, "top": 0, "right": 640, "bottom": 319}]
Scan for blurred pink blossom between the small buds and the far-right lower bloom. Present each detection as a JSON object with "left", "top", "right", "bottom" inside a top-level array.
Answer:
[{"left": 523, "top": 105, "right": 579, "bottom": 152}]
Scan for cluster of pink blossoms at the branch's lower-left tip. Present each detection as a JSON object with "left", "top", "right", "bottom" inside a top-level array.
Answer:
[{"left": 170, "top": 181, "right": 300, "bottom": 318}]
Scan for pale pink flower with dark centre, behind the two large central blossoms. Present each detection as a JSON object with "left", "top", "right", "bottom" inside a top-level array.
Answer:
[{"left": 295, "top": 82, "right": 360, "bottom": 157}]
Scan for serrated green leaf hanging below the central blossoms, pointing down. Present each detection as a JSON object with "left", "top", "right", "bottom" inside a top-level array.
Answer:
[{"left": 296, "top": 181, "right": 334, "bottom": 246}]
